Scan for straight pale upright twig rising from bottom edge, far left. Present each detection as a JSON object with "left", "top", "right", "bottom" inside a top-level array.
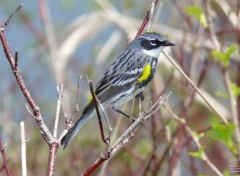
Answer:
[{"left": 20, "top": 122, "right": 27, "bottom": 176}]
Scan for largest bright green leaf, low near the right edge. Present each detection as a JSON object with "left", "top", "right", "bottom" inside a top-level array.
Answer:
[{"left": 207, "top": 119, "right": 237, "bottom": 154}]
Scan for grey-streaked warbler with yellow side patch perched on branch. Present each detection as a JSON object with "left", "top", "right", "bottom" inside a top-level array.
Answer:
[{"left": 61, "top": 32, "right": 174, "bottom": 148}]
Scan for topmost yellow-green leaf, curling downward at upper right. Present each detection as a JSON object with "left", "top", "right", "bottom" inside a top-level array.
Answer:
[{"left": 185, "top": 6, "right": 208, "bottom": 27}]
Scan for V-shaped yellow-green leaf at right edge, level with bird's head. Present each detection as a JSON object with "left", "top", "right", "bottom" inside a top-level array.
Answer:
[{"left": 212, "top": 45, "right": 238, "bottom": 68}]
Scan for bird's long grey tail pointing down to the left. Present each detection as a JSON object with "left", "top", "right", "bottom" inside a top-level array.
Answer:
[{"left": 61, "top": 106, "right": 94, "bottom": 149}]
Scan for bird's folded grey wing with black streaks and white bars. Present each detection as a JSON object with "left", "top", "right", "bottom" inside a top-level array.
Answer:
[{"left": 95, "top": 51, "right": 147, "bottom": 103}]
